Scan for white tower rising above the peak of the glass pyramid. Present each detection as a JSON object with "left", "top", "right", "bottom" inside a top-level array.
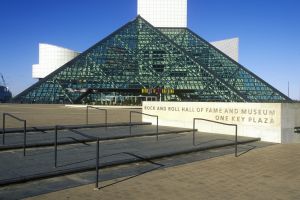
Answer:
[{"left": 138, "top": 0, "right": 187, "bottom": 27}]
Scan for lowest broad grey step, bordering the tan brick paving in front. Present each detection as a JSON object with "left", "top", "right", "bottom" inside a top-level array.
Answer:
[{"left": 0, "top": 133, "right": 260, "bottom": 186}]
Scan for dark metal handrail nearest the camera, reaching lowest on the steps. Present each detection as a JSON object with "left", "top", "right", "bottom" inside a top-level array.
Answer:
[{"left": 54, "top": 125, "right": 100, "bottom": 189}]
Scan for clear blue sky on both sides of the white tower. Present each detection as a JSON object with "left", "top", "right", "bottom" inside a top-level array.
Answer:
[{"left": 0, "top": 0, "right": 300, "bottom": 99}]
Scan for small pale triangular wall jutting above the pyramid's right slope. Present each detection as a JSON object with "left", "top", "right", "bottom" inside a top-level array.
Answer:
[{"left": 211, "top": 38, "right": 239, "bottom": 62}]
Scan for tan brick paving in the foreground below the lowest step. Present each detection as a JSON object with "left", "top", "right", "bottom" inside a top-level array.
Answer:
[{"left": 24, "top": 144, "right": 300, "bottom": 200}]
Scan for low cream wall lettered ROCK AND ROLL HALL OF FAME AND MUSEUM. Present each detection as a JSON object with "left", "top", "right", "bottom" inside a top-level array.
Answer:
[{"left": 143, "top": 102, "right": 300, "bottom": 143}]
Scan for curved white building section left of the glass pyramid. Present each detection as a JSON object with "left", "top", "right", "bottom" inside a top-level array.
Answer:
[{"left": 32, "top": 43, "right": 80, "bottom": 78}]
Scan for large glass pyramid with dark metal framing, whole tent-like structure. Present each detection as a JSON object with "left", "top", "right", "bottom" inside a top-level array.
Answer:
[{"left": 13, "top": 16, "right": 292, "bottom": 104}]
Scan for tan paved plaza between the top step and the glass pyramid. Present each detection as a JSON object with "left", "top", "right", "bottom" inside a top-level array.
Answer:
[{"left": 0, "top": 104, "right": 142, "bottom": 128}]
